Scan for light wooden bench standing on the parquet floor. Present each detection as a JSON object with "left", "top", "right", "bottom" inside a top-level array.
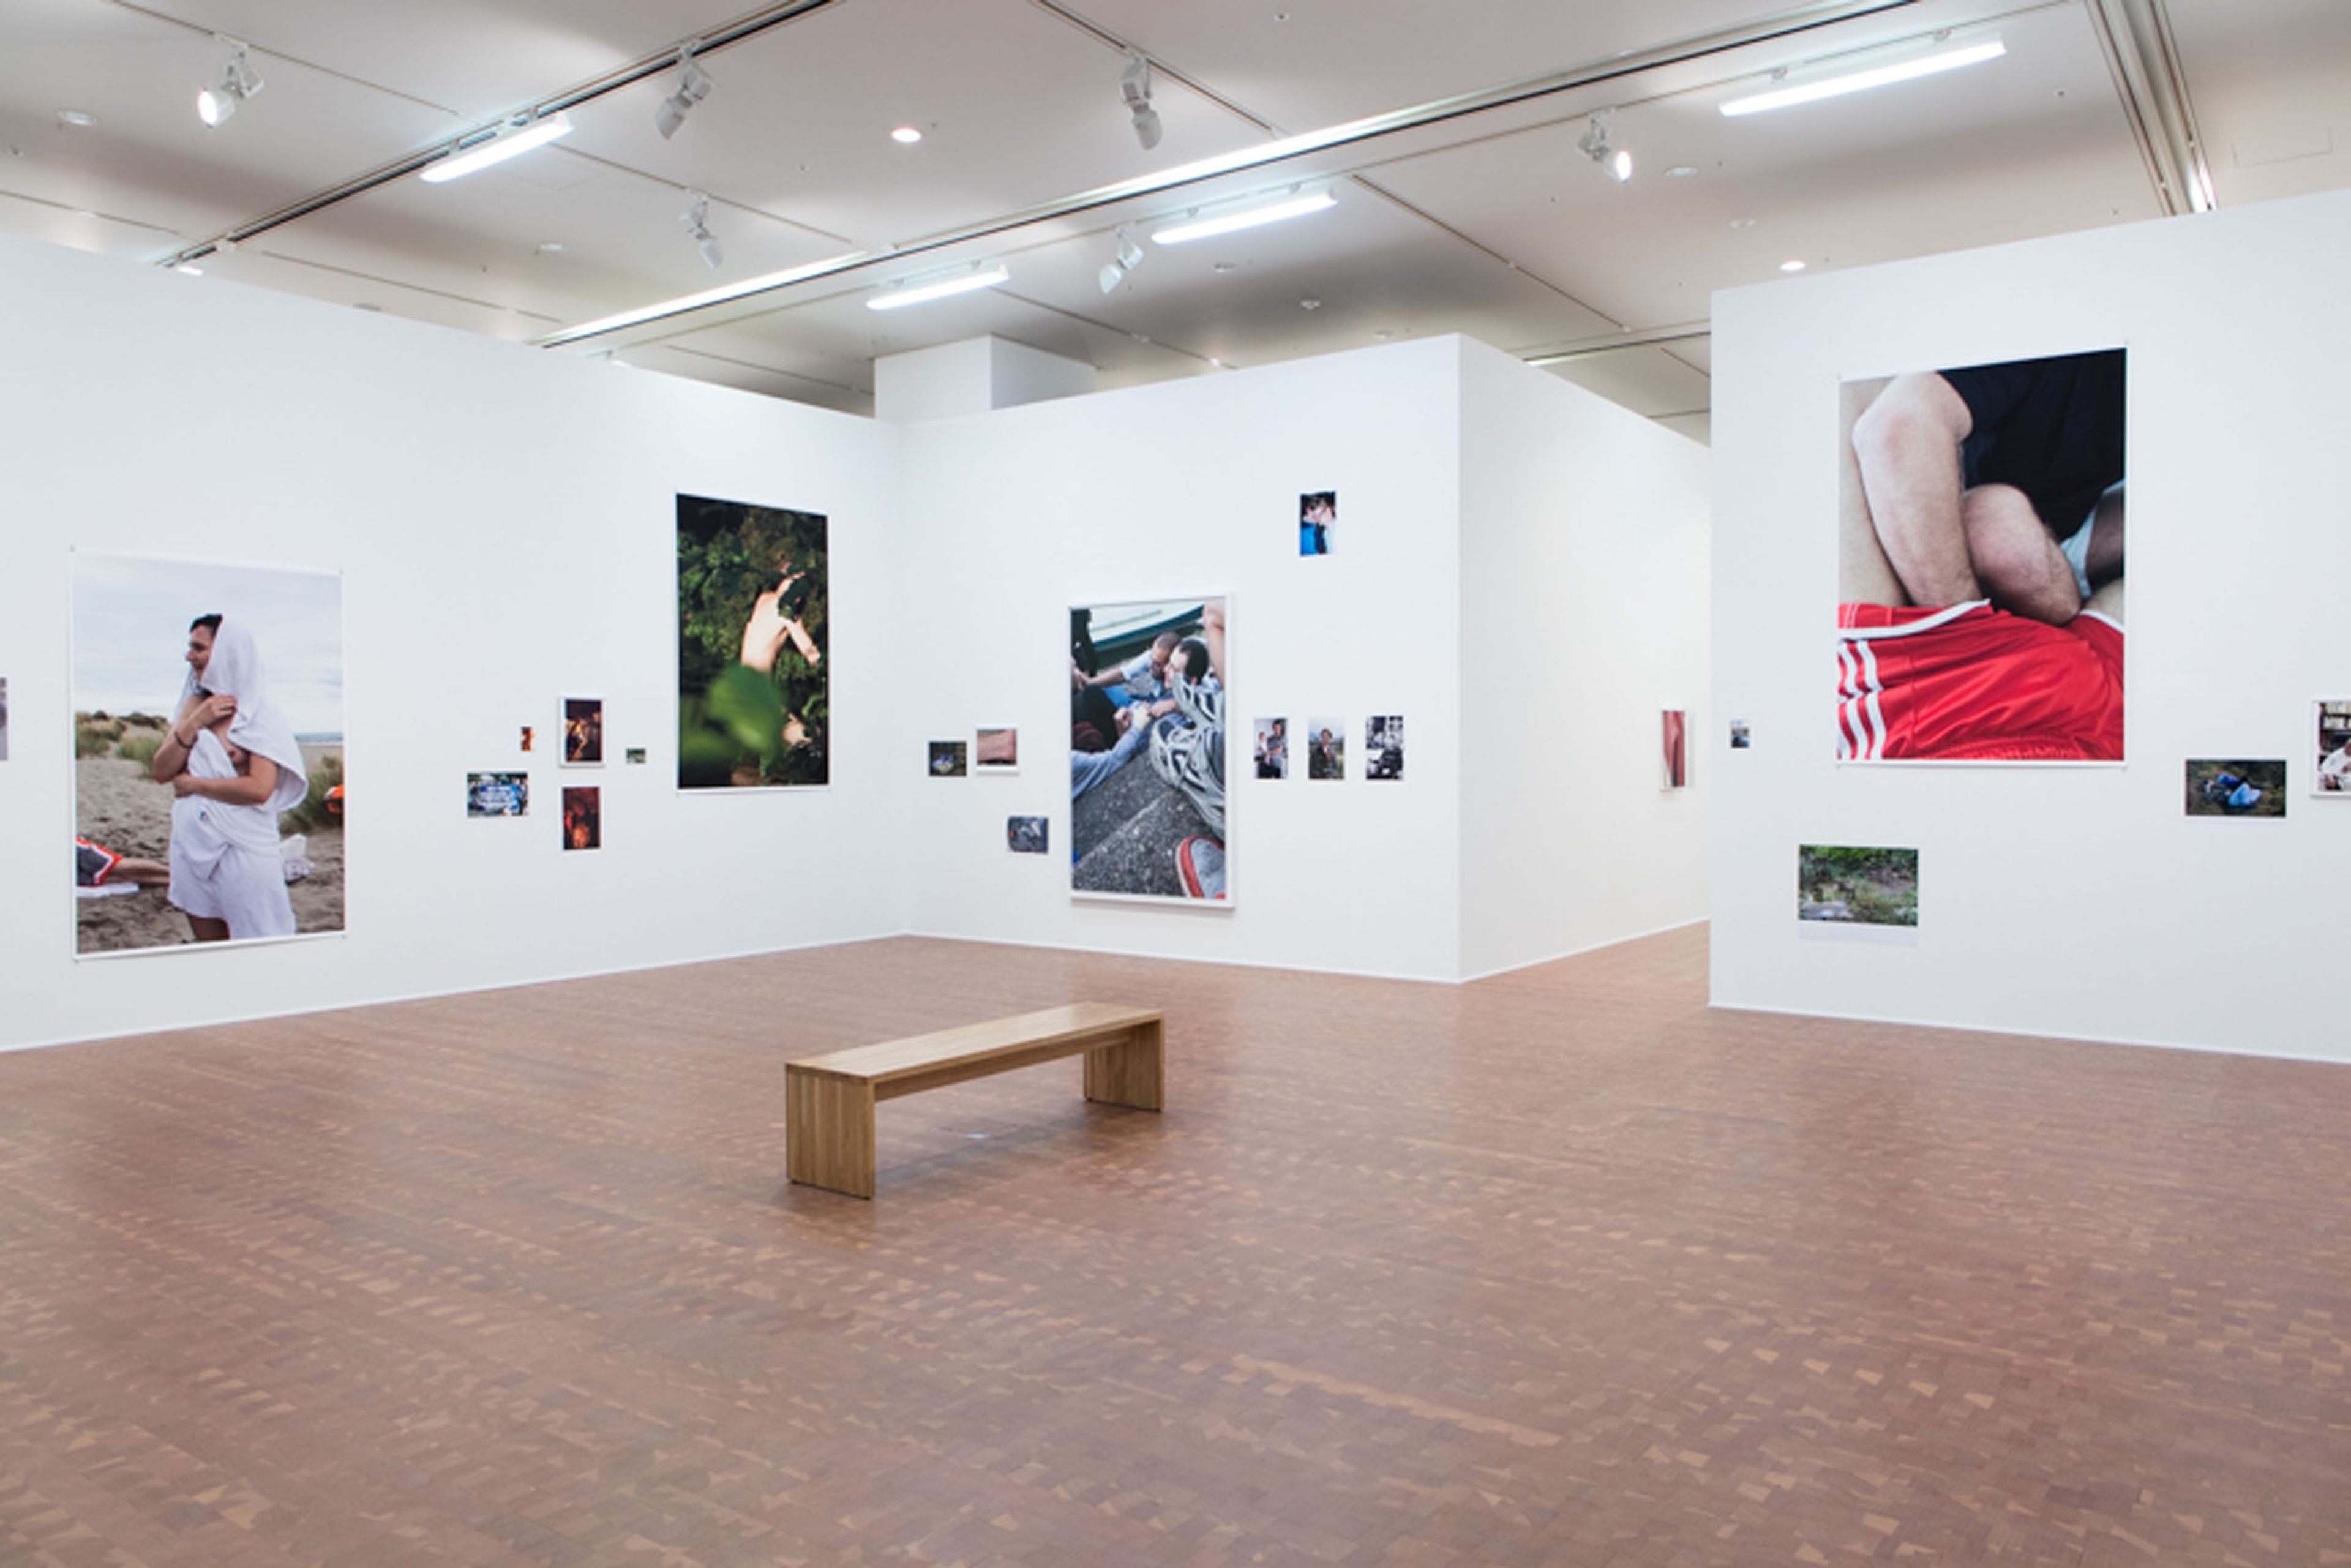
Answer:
[{"left": 783, "top": 1002, "right": 1166, "bottom": 1199}]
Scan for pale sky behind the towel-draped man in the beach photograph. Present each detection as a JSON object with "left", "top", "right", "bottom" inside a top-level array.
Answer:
[{"left": 73, "top": 552, "right": 343, "bottom": 738}]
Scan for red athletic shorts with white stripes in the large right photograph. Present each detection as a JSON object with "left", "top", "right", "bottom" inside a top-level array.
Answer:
[{"left": 1836, "top": 599, "right": 2123, "bottom": 762}]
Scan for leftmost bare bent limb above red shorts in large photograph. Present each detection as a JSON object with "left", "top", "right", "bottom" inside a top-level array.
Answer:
[{"left": 1845, "top": 373, "right": 1987, "bottom": 607}]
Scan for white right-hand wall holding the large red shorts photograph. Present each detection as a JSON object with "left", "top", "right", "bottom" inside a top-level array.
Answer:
[{"left": 1702, "top": 193, "right": 2351, "bottom": 1060}]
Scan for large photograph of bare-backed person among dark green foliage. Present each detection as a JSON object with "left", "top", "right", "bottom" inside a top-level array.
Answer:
[{"left": 677, "top": 496, "right": 830, "bottom": 790}]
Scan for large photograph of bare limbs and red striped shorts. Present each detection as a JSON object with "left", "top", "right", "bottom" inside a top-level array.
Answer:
[{"left": 1836, "top": 348, "right": 2125, "bottom": 762}]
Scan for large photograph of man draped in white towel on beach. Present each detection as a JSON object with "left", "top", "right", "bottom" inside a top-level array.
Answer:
[{"left": 73, "top": 555, "right": 343, "bottom": 955}]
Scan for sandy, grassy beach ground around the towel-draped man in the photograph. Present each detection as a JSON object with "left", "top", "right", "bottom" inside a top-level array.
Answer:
[{"left": 78, "top": 743, "right": 343, "bottom": 952}]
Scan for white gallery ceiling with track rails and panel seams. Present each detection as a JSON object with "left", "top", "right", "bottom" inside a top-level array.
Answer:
[{"left": 0, "top": 0, "right": 2351, "bottom": 435}]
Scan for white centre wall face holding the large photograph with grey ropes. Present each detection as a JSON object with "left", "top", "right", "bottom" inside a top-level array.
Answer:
[{"left": 898, "top": 339, "right": 1460, "bottom": 980}]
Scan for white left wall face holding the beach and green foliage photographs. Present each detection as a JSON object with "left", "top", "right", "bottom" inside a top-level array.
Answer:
[{"left": 0, "top": 242, "right": 905, "bottom": 1046}]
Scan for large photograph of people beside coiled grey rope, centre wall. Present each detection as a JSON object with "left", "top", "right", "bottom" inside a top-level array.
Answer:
[{"left": 1070, "top": 595, "right": 1232, "bottom": 907}]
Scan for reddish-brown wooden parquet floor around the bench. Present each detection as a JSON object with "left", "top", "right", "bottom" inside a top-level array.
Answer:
[{"left": 0, "top": 929, "right": 2351, "bottom": 1568}]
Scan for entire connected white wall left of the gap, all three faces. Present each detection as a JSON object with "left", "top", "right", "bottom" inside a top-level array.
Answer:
[{"left": 0, "top": 233, "right": 1704, "bottom": 1048}]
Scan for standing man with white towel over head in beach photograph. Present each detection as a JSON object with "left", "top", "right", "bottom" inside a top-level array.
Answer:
[{"left": 155, "top": 616, "right": 310, "bottom": 943}]
